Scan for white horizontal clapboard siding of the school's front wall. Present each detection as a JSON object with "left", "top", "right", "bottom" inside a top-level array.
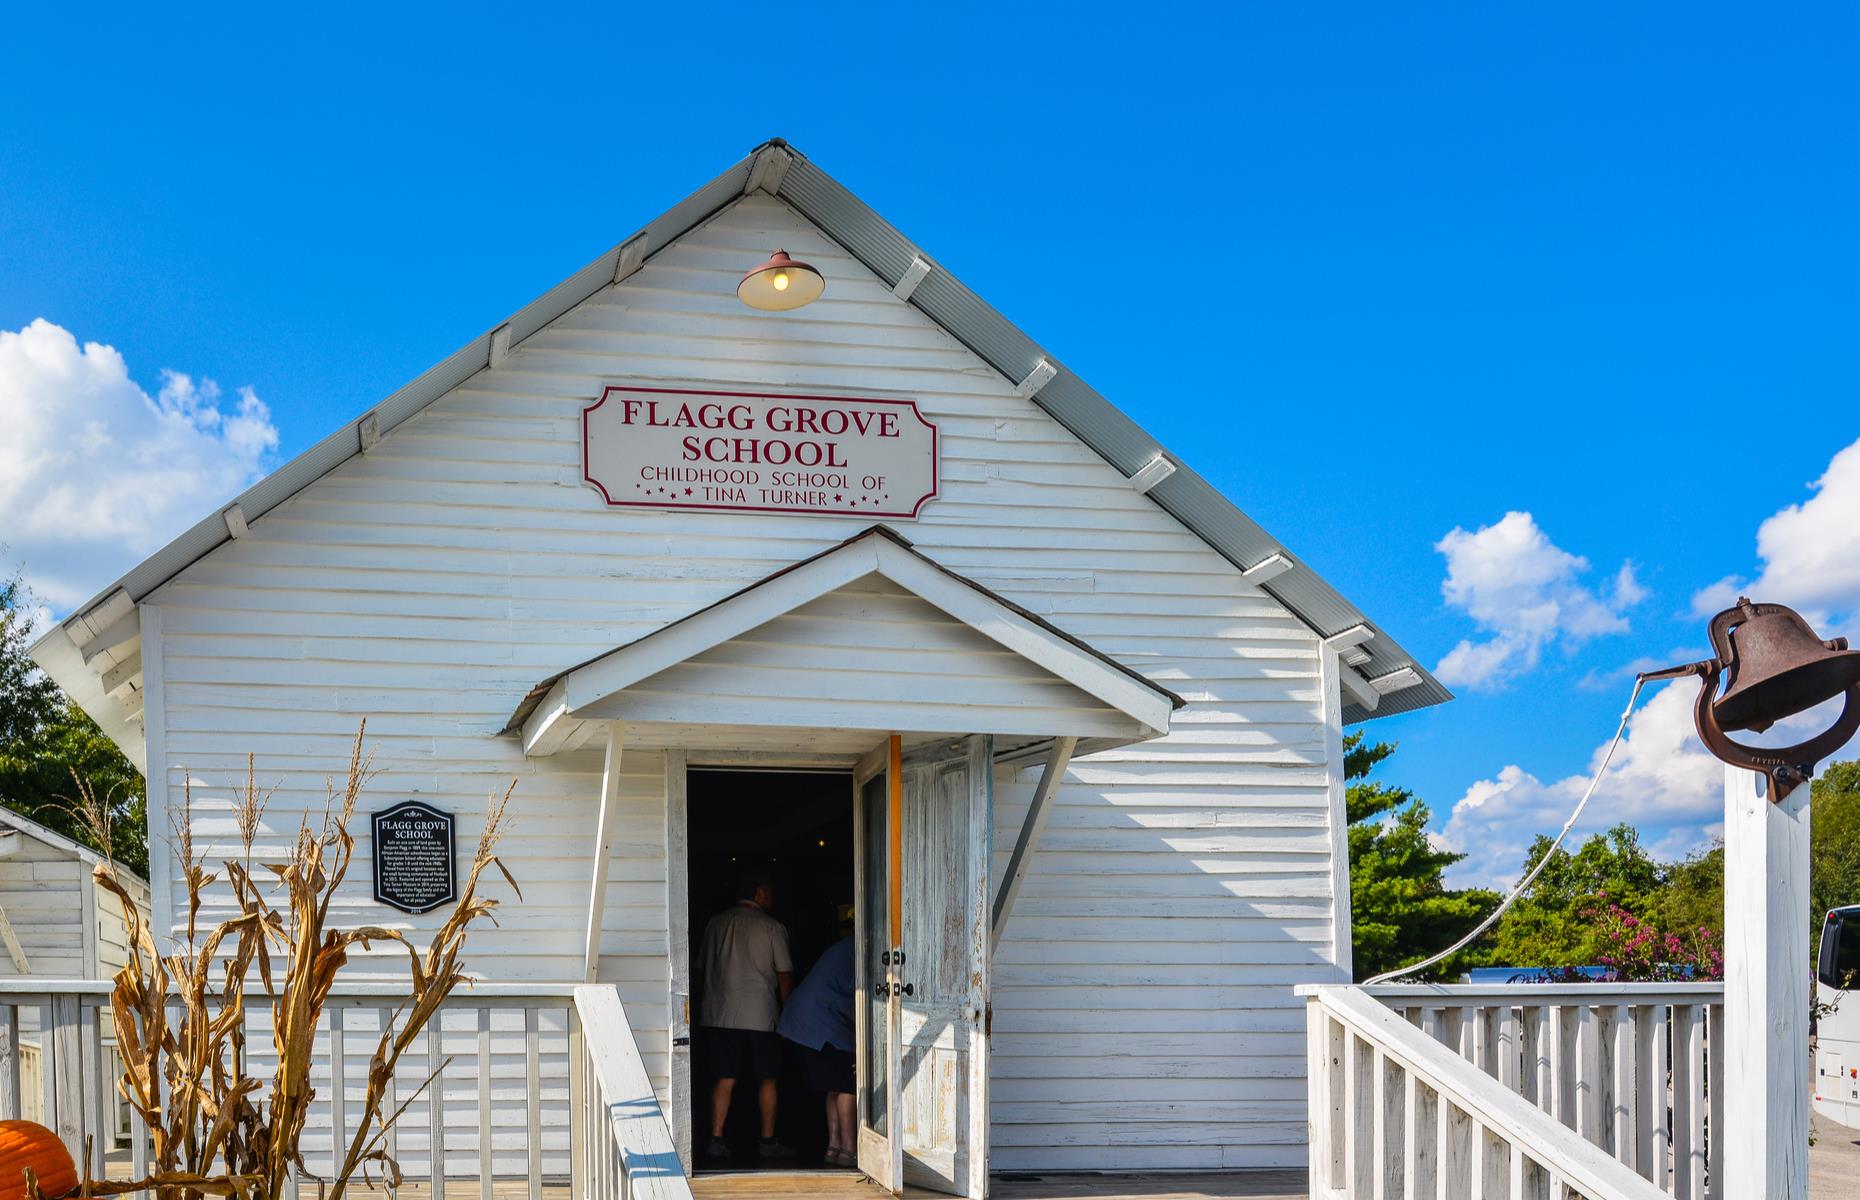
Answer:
[{"left": 149, "top": 195, "right": 1337, "bottom": 1168}]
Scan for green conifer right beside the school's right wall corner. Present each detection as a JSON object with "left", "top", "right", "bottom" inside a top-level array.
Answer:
[{"left": 1343, "top": 733, "right": 1499, "bottom": 979}]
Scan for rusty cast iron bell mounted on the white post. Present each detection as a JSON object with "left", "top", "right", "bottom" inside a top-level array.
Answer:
[{"left": 1641, "top": 595, "right": 1860, "bottom": 802}]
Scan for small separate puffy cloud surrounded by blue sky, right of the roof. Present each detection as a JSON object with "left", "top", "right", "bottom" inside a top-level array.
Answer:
[{"left": 1434, "top": 512, "right": 1646, "bottom": 688}]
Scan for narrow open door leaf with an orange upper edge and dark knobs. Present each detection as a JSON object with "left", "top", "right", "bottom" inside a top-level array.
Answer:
[{"left": 852, "top": 739, "right": 904, "bottom": 1193}]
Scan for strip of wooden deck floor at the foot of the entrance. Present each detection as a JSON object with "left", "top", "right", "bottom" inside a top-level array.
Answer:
[{"left": 692, "top": 1170, "right": 1306, "bottom": 1200}]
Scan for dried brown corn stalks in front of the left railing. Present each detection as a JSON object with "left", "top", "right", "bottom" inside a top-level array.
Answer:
[{"left": 50, "top": 722, "right": 523, "bottom": 1200}]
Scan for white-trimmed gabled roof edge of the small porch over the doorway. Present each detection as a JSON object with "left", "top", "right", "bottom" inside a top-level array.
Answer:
[{"left": 502, "top": 525, "right": 1185, "bottom": 753}]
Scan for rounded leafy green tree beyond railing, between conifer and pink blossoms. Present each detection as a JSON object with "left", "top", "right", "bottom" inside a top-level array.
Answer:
[{"left": 1486, "top": 824, "right": 1674, "bottom": 967}]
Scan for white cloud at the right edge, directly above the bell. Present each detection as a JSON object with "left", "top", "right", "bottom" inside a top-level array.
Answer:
[{"left": 1693, "top": 441, "right": 1860, "bottom": 636}]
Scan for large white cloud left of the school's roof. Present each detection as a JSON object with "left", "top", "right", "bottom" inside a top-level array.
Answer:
[{"left": 0, "top": 318, "right": 277, "bottom": 612}]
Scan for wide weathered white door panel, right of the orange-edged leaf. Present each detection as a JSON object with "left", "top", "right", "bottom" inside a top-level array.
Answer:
[{"left": 893, "top": 737, "right": 993, "bottom": 1198}]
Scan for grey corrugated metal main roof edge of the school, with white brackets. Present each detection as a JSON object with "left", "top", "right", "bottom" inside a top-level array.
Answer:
[{"left": 32, "top": 140, "right": 1453, "bottom": 725}]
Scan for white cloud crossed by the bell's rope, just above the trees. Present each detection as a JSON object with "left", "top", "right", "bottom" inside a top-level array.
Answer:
[{"left": 1440, "top": 679, "right": 1724, "bottom": 886}]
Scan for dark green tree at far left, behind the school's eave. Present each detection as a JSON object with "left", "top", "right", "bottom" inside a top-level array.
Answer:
[{"left": 0, "top": 573, "right": 149, "bottom": 874}]
